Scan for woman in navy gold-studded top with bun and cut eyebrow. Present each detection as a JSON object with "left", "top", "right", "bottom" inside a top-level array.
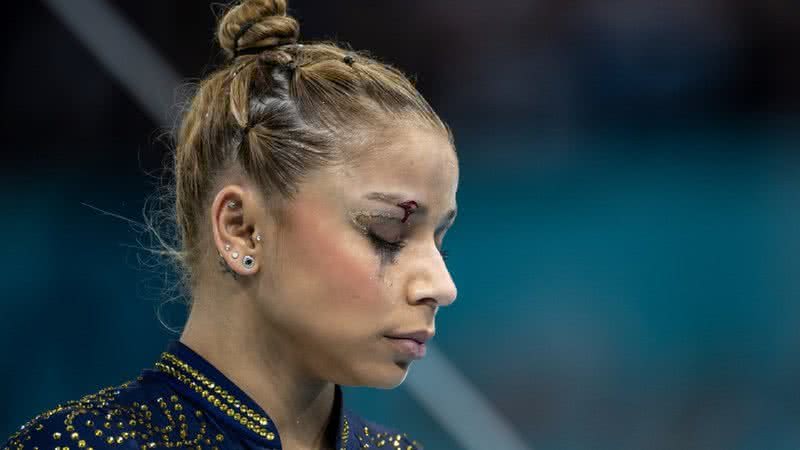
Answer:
[{"left": 7, "top": 0, "right": 458, "bottom": 450}]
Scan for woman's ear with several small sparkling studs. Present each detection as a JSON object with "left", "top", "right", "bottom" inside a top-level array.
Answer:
[{"left": 211, "top": 184, "right": 266, "bottom": 276}]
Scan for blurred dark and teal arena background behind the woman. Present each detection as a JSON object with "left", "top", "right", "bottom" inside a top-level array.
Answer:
[{"left": 0, "top": 0, "right": 800, "bottom": 450}]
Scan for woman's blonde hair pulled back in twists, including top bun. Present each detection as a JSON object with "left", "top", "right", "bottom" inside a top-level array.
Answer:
[{"left": 164, "top": 0, "right": 452, "bottom": 294}]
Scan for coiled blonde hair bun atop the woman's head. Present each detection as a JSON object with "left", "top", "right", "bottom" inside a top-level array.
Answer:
[{"left": 217, "top": 0, "right": 300, "bottom": 58}]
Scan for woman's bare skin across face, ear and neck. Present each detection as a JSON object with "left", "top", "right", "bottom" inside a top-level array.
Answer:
[{"left": 181, "top": 126, "right": 458, "bottom": 448}]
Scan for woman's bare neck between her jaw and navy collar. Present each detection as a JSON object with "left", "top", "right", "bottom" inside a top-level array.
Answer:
[{"left": 180, "top": 293, "right": 338, "bottom": 449}]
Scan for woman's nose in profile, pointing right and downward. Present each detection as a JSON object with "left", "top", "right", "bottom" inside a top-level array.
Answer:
[{"left": 408, "top": 241, "right": 458, "bottom": 306}]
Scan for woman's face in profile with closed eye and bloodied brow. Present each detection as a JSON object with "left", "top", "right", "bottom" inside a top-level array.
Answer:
[{"left": 259, "top": 127, "right": 458, "bottom": 387}]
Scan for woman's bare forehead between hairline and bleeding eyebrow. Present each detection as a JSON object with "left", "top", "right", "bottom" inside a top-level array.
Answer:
[{"left": 342, "top": 126, "right": 458, "bottom": 199}]
